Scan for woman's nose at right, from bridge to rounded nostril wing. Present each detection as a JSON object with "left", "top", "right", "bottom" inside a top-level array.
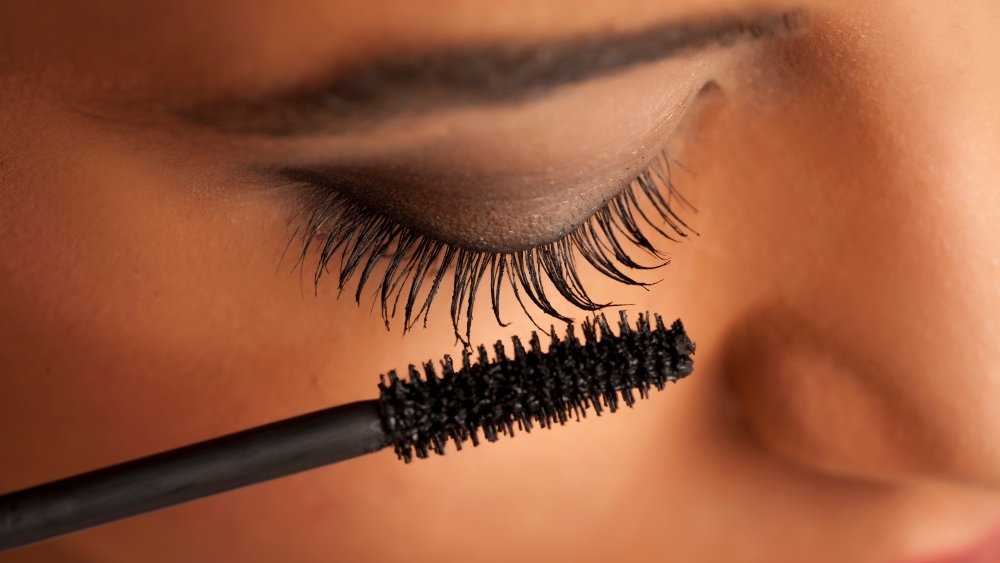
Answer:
[{"left": 704, "top": 0, "right": 1000, "bottom": 486}]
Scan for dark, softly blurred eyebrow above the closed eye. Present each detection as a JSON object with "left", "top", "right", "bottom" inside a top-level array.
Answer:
[{"left": 179, "top": 12, "right": 803, "bottom": 137}]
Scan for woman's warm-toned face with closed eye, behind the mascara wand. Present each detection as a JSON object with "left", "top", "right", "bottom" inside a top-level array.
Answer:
[{"left": 0, "top": 0, "right": 1000, "bottom": 563}]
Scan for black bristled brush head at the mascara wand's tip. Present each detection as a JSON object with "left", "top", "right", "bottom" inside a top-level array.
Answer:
[{"left": 379, "top": 312, "right": 695, "bottom": 463}]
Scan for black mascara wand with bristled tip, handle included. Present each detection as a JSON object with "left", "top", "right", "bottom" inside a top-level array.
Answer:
[{"left": 0, "top": 312, "right": 694, "bottom": 551}]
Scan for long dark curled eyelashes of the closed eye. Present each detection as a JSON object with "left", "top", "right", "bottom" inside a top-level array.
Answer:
[{"left": 289, "top": 154, "right": 694, "bottom": 344}]
